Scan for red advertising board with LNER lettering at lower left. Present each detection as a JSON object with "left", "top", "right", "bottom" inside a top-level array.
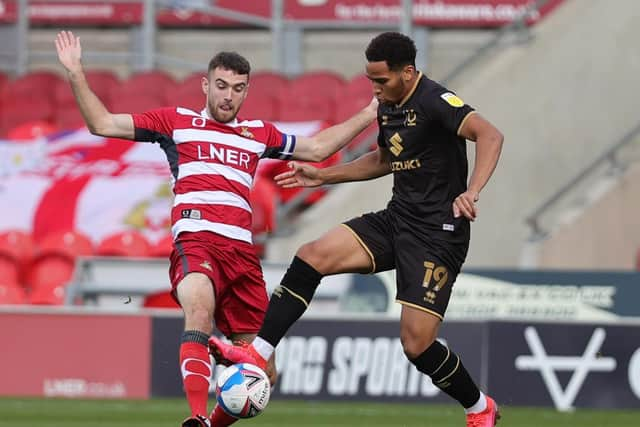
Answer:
[{"left": 0, "top": 313, "right": 151, "bottom": 399}]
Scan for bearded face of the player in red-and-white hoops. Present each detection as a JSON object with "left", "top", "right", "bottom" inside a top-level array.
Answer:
[{"left": 202, "top": 67, "right": 249, "bottom": 123}]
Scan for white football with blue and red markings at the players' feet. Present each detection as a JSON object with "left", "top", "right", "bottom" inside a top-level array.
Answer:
[{"left": 216, "top": 363, "right": 271, "bottom": 418}]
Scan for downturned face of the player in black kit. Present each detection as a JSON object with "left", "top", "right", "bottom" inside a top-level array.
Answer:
[{"left": 367, "top": 61, "right": 413, "bottom": 104}]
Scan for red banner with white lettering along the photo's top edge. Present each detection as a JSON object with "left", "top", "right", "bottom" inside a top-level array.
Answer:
[{"left": 0, "top": 0, "right": 563, "bottom": 27}]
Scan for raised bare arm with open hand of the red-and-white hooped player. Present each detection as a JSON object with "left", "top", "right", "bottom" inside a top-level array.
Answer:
[{"left": 55, "top": 31, "right": 134, "bottom": 139}]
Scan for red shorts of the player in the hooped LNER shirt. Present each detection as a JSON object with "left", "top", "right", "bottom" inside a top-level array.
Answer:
[{"left": 169, "top": 231, "right": 269, "bottom": 337}]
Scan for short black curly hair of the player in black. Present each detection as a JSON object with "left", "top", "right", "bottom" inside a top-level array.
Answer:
[{"left": 365, "top": 31, "right": 416, "bottom": 71}]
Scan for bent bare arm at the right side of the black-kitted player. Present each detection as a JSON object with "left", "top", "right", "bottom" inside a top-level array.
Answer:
[{"left": 453, "top": 113, "right": 504, "bottom": 221}]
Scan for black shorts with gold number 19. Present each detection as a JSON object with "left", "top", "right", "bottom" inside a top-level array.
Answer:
[{"left": 343, "top": 210, "right": 469, "bottom": 320}]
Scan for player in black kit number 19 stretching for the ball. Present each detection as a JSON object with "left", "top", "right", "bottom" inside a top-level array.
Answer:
[{"left": 209, "top": 32, "right": 503, "bottom": 427}]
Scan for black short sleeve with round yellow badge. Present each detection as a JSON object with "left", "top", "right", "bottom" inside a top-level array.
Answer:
[{"left": 422, "top": 87, "right": 475, "bottom": 135}]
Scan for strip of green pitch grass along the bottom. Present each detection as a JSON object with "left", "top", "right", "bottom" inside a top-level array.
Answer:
[{"left": 0, "top": 398, "right": 640, "bottom": 427}]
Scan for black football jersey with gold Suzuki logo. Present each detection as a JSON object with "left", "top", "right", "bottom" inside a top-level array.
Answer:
[{"left": 378, "top": 73, "right": 474, "bottom": 234}]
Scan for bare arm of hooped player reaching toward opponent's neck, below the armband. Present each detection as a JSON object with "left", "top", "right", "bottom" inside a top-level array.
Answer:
[{"left": 293, "top": 98, "right": 378, "bottom": 162}]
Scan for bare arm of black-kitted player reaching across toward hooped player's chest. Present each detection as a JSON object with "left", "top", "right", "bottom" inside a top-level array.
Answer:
[{"left": 275, "top": 147, "right": 391, "bottom": 188}]
